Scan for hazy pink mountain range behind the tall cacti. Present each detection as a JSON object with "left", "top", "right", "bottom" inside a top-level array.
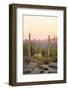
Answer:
[{"left": 23, "top": 38, "right": 57, "bottom": 48}]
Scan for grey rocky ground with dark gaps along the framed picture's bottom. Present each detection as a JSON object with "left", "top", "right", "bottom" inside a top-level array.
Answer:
[{"left": 23, "top": 56, "right": 57, "bottom": 74}]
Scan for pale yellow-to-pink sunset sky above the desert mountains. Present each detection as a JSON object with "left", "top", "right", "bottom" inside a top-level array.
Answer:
[{"left": 23, "top": 15, "right": 58, "bottom": 40}]
